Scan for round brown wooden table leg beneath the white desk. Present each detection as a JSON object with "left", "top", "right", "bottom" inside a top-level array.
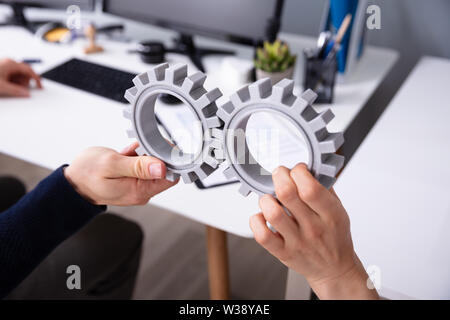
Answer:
[{"left": 206, "top": 226, "right": 229, "bottom": 300}]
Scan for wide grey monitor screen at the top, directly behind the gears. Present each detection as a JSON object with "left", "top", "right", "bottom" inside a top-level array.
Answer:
[{"left": 104, "top": 0, "right": 282, "bottom": 43}]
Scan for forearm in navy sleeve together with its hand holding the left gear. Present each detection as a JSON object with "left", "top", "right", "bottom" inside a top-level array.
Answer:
[{"left": 0, "top": 144, "right": 176, "bottom": 298}]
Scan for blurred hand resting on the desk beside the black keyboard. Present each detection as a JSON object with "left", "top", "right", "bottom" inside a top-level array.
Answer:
[{"left": 0, "top": 59, "right": 42, "bottom": 97}]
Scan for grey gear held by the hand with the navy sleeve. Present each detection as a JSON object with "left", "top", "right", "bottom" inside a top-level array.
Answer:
[{"left": 123, "top": 63, "right": 222, "bottom": 183}]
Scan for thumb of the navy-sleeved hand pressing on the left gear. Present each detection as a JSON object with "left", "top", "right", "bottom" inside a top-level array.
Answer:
[{"left": 115, "top": 155, "right": 166, "bottom": 180}]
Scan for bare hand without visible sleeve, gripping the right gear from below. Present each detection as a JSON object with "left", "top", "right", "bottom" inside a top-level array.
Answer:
[{"left": 250, "top": 164, "right": 379, "bottom": 299}]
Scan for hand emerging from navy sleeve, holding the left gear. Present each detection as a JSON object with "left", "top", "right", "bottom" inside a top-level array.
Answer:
[{"left": 64, "top": 142, "right": 178, "bottom": 206}]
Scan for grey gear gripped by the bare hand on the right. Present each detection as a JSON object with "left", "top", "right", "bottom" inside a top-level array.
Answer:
[{"left": 213, "top": 78, "right": 344, "bottom": 196}]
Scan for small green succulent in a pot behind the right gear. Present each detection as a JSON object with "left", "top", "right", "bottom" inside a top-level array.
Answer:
[{"left": 255, "top": 40, "right": 297, "bottom": 84}]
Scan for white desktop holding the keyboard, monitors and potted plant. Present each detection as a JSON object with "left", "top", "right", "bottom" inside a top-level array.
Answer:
[{"left": 0, "top": 27, "right": 397, "bottom": 237}]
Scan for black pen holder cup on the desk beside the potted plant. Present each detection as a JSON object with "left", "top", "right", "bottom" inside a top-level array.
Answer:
[{"left": 303, "top": 49, "right": 337, "bottom": 103}]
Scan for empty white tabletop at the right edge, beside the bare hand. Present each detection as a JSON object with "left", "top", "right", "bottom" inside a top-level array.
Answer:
[{"left": 335, "top": 57, "right": 450, "bottom": 299}]
